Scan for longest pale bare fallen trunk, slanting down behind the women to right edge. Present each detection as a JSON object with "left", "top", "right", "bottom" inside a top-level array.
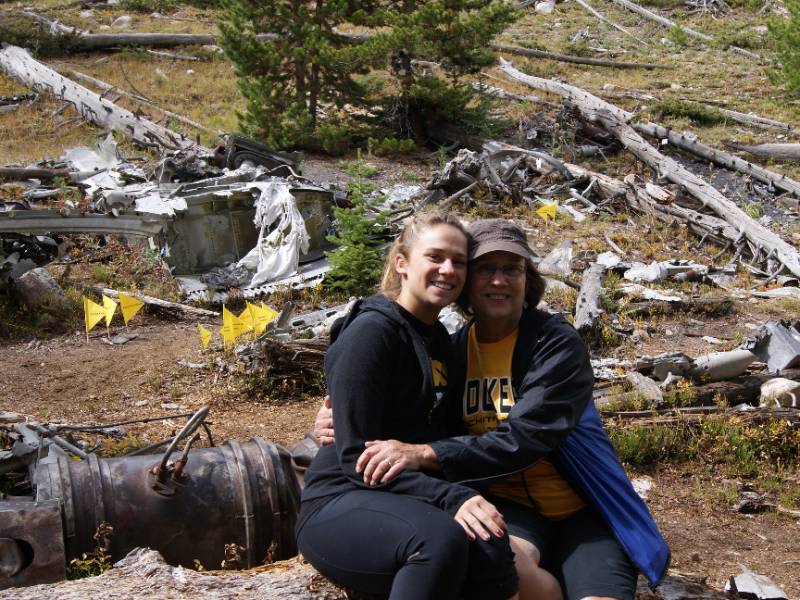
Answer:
[{"left": 501, "top": 59, "right": 800, "bottom": 276}]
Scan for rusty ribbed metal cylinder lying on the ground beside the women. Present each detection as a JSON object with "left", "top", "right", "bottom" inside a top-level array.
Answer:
[{"left": 34, "top": 438, "right": 300, "bottom": 569}]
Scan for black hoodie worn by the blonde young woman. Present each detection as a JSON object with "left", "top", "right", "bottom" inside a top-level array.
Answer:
[{"left": 300, "top": 295, "right": 477, "bottom": 524}]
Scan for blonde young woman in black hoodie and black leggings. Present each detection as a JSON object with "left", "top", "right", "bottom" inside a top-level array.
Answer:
[{"left": 297, "top": 213, "right": 517, "bottom": 600}]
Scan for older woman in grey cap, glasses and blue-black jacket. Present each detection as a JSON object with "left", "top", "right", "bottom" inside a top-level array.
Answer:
[{"left": 317, "top": 219, "right": 669, "bottom": 600}]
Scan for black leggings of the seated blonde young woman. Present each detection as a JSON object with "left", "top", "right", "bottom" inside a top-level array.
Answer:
[{"left": 297, "top": 490, "right": 517, "bottom": 600}]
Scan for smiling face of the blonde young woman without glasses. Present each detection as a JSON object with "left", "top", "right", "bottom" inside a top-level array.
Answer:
[{"left": 394, "top": 225, "right": 467, "bottom": 323}]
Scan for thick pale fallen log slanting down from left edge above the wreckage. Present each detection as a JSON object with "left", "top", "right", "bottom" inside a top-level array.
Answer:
[{"left": 0, "top": 46, "right": 205, "bottom": 154}]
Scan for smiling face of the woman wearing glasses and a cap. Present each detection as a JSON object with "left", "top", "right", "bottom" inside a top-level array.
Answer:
[{"left": 467, "top": 250, "right": 526, "bottom": 342}]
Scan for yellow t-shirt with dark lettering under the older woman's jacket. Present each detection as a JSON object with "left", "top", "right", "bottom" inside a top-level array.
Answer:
[{"left": 463, "top": 325, "right": 586, "bottom": 519}]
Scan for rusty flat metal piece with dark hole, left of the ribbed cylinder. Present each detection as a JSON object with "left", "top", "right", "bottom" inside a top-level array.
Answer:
[{"left": 0, "top": 500, "right": 66, "bottom": 590}]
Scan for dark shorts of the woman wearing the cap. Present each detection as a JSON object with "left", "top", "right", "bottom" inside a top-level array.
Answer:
[{"left": 487, "top": 495, "right": 638, "bottom": 600}]
